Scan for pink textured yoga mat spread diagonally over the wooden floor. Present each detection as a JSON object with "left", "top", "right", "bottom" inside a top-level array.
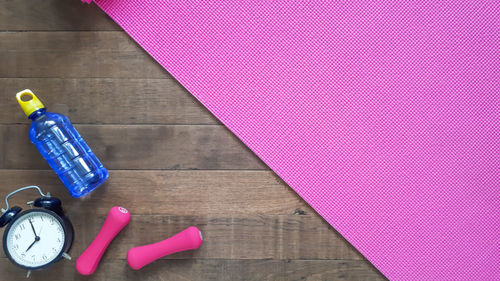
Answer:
[{"left": 84, "top": 0, "right": 500, "bottom": 280}]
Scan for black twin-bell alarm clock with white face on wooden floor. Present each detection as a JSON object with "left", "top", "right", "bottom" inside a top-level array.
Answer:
[{"left": 0, "top": 186, "right": 74, "bottom": 277}]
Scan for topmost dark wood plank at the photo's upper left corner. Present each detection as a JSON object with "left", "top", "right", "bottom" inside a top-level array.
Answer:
[{"left": 0, "top": 0, "right": 121, "bottom": 31}]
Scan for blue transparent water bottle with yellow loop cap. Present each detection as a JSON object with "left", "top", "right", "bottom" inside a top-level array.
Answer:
[{"left": 16, "top": 89, "right": 109, "bottom": 197}]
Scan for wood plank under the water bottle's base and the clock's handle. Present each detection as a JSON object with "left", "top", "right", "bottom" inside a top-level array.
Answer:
[{"left": 0, "top": 170, "right": 300, "bottom": 216}]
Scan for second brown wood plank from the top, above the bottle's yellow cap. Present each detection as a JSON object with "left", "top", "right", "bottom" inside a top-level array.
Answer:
[{"left": 0, "top": 31, "right": 171, "bottom": 78}]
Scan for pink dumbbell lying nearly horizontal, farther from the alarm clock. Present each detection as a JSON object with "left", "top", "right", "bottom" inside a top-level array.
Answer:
[{"left": 127, "top": 226, "right": 203, "bottom": 270}]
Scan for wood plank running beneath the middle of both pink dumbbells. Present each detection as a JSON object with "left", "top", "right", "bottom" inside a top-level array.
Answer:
[{"left": 72, "top": 214, "right": 364, "bottom": 260}]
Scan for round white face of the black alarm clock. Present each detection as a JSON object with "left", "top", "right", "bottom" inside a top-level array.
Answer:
[{"left": 4, "top": 209, "right": 65, "bottom": 269}]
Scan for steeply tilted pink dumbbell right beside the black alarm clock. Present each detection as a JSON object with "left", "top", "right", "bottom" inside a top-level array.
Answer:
[{"left": 76, "top": 207, "right": 130, "bottom": 275}]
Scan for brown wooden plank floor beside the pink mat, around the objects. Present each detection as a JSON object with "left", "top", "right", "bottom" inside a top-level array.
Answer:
[{"left": 0, "top": 0, "right": 384, "bottom": 281}]
